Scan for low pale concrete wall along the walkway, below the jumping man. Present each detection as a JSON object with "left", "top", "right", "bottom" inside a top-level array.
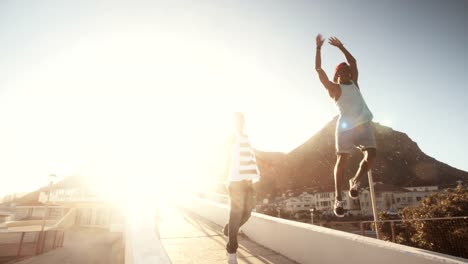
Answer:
[{"left": 183, "top": 198, "right": 468, "bottom": 264}]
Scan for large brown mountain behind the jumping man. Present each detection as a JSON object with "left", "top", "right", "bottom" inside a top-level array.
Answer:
[{"left": 256, "top": 118, "right": 468, "bottom": 198}]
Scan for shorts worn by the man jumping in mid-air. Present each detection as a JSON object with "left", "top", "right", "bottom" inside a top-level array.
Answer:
[{"left": 335, "top": 122, "right": 377, "bottom": 154}]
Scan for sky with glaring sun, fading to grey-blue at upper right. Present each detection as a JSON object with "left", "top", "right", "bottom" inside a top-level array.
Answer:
[{"left": 0, "top": 0, "right": 468, "bottom": 196}]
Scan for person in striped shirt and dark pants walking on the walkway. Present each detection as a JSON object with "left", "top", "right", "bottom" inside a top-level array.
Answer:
[{"left": 223, "top": 112, "right": 260, "bottom": 264}]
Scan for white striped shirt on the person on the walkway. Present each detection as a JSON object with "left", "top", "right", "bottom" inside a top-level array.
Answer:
[{"left": 229, "top": 133, "right": 260, "bottom": 182}]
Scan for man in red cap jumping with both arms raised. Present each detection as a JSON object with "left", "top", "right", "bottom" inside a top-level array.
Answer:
[{"left": 315, "top": 34, "right": 377, "bottom": 217}]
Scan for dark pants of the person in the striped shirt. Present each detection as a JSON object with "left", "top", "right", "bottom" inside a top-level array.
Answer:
[{"left": 226, "top": 181, "right": 255, "bottom": 253}]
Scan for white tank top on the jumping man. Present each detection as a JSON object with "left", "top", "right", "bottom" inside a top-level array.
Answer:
[{"left": 335, "top": 82, "right": 373, "bottom": 133}]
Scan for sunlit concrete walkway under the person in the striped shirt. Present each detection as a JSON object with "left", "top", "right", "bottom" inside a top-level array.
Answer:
[{"left": 157, "top": 207, "right": 295, "bottom": 264}]
